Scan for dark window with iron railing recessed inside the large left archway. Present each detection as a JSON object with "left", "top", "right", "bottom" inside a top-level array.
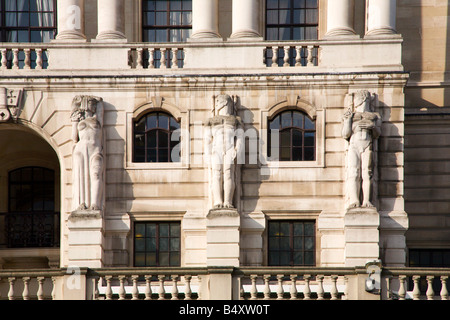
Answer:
[{"left": 5, "top": 167, "right": 59, "bottom": 247}]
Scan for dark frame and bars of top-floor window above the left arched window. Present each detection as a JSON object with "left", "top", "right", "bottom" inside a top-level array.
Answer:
[{"left": 141, "top": 0, "right": 192, "bottom": 43}]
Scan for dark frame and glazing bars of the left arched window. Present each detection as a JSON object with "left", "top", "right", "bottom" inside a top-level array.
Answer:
[{"left": 131, "top": 110, "right": 182, "bottom": 164}]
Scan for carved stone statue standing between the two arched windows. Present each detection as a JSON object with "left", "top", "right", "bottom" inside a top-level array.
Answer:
[{"left": 205, "top": 94, "right": 243, "bottom": 209}]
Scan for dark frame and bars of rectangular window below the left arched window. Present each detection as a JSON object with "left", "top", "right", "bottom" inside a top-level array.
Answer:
[{"left": 133, "top": 220, "right": 182, "bottom": 268}]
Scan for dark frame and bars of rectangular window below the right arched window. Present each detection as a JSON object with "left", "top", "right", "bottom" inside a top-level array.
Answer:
[{"left": 266, "top": 219, "right": 317, "bottom": 267}]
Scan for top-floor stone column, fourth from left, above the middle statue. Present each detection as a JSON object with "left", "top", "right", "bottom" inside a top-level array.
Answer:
[{"left": 231, "top": 0, "right": 261, "bottom": 39}]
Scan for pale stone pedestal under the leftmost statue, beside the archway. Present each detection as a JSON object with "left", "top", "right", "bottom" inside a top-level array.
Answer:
[{"left": 67, "top": 210, "right": 105, "bottom": 268}]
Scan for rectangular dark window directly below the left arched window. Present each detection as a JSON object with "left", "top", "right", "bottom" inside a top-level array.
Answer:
[{"left": 134, "top": 222, "right": 181, "bottom": 267}]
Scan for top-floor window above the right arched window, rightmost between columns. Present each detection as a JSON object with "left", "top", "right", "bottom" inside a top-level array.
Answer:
[{"left": 266, "top": 0, "right": 318, "bottom": 40}]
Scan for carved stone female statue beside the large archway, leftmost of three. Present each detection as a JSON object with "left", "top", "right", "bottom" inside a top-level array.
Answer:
[{"left": 71, "top": 96, "right": 105, "bottom": 211}]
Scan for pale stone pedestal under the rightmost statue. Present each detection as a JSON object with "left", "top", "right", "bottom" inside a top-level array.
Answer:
[{"left": 344, "top": 208, "right": 380, "bottom": 267}]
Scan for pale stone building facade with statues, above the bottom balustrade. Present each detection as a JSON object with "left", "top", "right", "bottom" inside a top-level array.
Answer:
[{"left": 0, "top": 0, "right": 450, "bottom": 300}]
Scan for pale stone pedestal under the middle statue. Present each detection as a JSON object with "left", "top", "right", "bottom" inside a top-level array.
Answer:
[{"left": 206, "top": 209, "right": 241, "bottom": 267}]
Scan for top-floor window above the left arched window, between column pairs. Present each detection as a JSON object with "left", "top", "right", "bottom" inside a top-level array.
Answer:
[{"left": 142, "top": 0, "right": 192, "bottom": 42}]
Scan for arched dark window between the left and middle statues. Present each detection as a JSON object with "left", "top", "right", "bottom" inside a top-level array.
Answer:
[{"left": 133, "top": 112, "right": 180, "bottom": 162}]
